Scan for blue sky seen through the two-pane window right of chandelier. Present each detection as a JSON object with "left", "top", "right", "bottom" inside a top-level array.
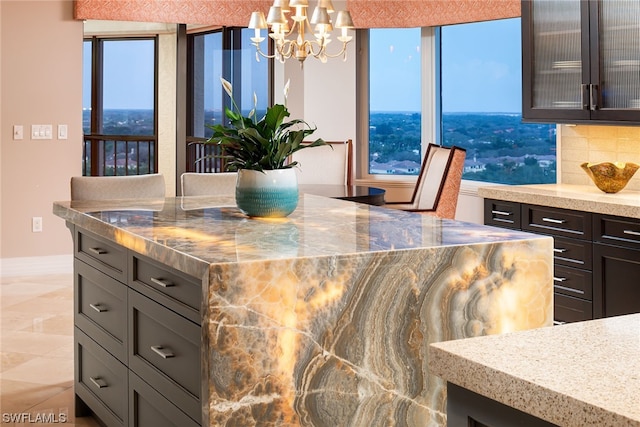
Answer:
[{"left": 370, "top": 18, "right": 522, "bottom": 112}]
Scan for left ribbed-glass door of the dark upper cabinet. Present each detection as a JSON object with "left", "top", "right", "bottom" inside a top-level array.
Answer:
[{"left": 522, "top": 0, "right": 590, "bottom": 121}]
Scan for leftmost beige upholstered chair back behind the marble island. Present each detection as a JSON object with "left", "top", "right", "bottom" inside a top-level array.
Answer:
[{"left": 71, "top": 174, "right": 166, "bottom": 201}]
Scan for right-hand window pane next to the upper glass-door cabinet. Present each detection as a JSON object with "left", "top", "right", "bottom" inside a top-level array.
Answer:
[{"left": 438, "top": 18, "right": 556, "bottom": 184}]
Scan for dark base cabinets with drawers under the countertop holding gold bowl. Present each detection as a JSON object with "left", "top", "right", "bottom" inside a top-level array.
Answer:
[{"left": 484, "top": 199, "right": 640, "bottom": 324}]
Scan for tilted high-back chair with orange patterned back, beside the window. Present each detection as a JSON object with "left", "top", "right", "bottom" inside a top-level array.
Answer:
[{"left": 385, "top": 144, "right": 466, "bottom": 219}]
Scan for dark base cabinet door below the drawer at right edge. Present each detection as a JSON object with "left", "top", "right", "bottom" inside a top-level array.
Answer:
[{"left": 593, "top": 243, "right": 640, "bottom": 318}]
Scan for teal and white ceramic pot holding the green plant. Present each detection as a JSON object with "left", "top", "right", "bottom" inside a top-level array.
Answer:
[{"left": 236, "top": 168, "right": 298, "bottom": 218}]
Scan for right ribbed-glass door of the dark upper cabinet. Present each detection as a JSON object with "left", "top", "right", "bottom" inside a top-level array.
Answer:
[{"left": 590, "top": 0, "right": 640, "bottom": 122}]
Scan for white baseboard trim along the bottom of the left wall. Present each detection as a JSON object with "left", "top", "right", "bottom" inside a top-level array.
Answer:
[{"left": 0, "top": 254, "right": 73, "bottom": 277}]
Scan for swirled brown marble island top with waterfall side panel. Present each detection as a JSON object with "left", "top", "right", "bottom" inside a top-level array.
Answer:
[{"left": 53, "top": 194, "right": 553, "bottom": 427}]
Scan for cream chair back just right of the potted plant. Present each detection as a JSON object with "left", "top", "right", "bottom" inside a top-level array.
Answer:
[{"left": 291, "top": 139, "right": 353, "bottom": 185}]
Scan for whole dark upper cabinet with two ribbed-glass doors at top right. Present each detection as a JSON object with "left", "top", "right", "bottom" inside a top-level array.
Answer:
[{"left": 522, "top": 0, "right": 640, "bottom": 124}]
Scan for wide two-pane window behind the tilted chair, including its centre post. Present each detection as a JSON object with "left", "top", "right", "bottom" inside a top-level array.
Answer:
[{"left": 366, "top": 18, "right": 556, "bottom": 184}]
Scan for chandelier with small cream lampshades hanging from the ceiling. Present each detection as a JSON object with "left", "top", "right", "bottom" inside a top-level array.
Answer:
[{"left": 249, "top": 0, "right": 354, "bottom": 67}]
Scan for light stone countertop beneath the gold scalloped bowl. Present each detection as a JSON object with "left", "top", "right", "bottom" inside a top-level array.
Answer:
[{"left": 478, "top": 184, "right": 640, "bottom": 219}]
